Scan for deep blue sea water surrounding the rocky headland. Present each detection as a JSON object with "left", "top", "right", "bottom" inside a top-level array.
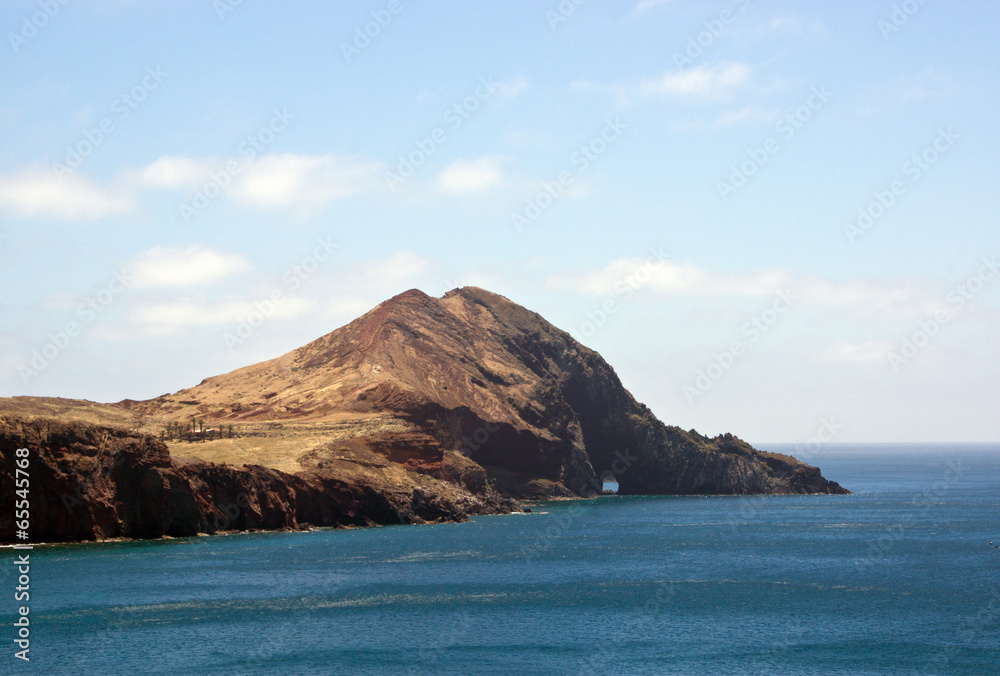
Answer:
[{"left": 0, "top": 445, "right": 1000, "bottom": 674}]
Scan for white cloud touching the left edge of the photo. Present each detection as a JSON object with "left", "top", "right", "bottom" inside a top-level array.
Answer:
[{"left": 0, "top": 169, "right": 134, "bottom": 220}]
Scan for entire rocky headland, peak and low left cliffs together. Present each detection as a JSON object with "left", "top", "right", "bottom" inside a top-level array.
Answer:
[{"left": 0, "top": 287, "right": 848, "bottom": 541}]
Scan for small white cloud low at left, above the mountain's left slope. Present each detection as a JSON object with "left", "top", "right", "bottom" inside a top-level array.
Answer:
[{"left": 129, "top": 244, "right": 250, "bottom": 288}]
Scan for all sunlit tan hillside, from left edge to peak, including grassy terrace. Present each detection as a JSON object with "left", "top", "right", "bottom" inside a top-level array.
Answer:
[{"left": 0, "top": 289, "right": 585, "bottom": 486}]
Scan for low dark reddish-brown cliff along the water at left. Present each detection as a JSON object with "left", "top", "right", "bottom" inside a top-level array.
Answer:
[{"left": 0, "top": 418, "right": 515, "bottom": 542}]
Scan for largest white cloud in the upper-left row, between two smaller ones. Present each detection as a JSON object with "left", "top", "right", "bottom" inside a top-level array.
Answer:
[{"left": 232, "top": 153, "right": 381, "bottom": 207}]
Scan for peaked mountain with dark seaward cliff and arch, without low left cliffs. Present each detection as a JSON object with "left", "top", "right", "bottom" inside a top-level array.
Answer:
[{"left": 155, "top": 287, "right": 843, "bottom": 497}]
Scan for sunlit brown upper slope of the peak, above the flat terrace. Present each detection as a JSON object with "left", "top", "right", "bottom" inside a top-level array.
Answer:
[{"left": 149, "top": 289, "right": 561, "bottom": 423}]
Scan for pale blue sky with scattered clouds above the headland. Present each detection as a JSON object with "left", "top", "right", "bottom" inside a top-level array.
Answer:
[{"left": 0, "top": 0, "right": 1000, "bottom": 448}]
